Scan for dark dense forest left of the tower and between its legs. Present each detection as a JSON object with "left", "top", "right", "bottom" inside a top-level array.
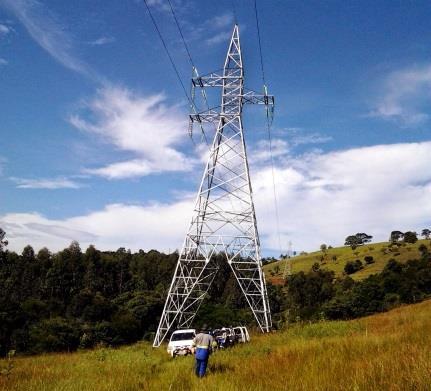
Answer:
[{"left": 0, "top": 242, "right": 251, "bottom": 355}]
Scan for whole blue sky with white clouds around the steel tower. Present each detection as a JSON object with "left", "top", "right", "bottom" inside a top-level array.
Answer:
[{"left": 0, "top": 0, "right": 431, "bottom": 254}]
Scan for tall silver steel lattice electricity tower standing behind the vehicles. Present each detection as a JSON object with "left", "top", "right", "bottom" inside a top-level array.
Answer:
[{"left": 153, "top": 25, "right": 274, "bottom": 346}]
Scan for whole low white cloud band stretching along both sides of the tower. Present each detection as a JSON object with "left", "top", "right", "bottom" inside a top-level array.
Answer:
[{"left": 0, "top": 142, "right": 431, "bottom": 251}]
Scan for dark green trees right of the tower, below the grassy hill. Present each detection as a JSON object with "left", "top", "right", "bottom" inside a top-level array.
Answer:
[{"left": 276, "top": 246, "right": 431, "bottom": 322}]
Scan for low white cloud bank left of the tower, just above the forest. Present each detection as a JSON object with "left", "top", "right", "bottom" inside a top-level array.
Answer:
[{"left": 0, "top": 200, "right": 192, "bottom": 251}]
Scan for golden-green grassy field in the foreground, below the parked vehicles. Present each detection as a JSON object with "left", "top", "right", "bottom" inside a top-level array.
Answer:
[{"left": 0, "top": 300, "right": 431, "bottom": 391}]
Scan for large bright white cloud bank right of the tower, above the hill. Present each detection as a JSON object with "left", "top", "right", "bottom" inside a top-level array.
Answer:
[{"left": 254, "top": 142, "right": 431, "bottom": 250}]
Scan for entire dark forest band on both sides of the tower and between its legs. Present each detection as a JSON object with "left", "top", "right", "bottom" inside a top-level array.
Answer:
[{"left": 0, "top": 234, "right": 431, "bottom": 356}]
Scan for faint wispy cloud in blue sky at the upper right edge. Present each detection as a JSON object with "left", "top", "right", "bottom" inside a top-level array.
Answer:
[{"left": 371, "top": 65, "right": 431, "bottom": 126}]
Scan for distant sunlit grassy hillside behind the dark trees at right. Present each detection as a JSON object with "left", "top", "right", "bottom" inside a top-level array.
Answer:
[{"left": 264, "top": 239, "right": 430, "bottom": 283}]
